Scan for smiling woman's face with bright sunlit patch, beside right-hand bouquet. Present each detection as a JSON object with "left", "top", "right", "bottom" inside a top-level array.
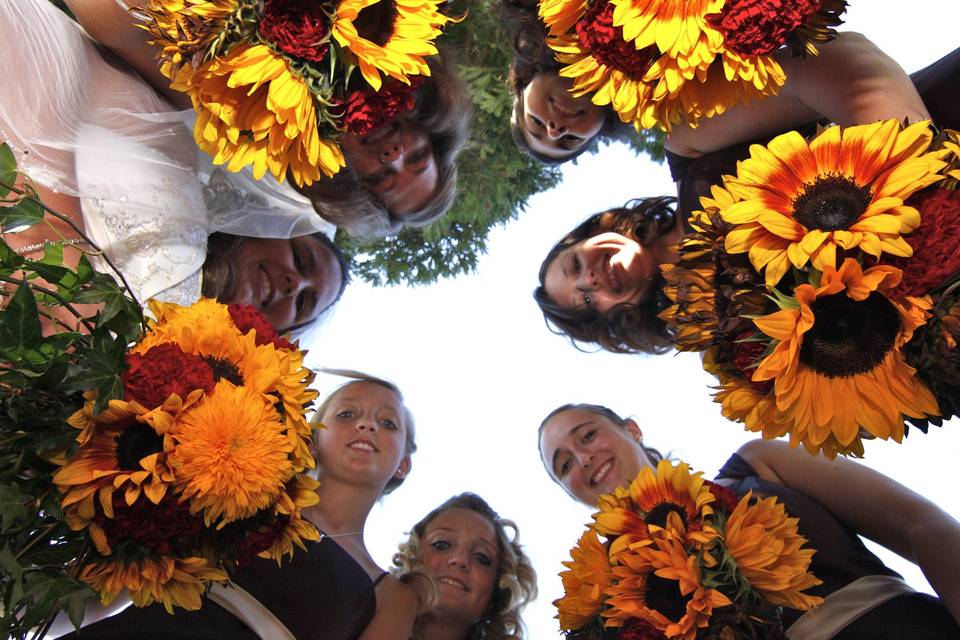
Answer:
[{"left": 543, "top": 231, "right": 659, "bottom": 313}]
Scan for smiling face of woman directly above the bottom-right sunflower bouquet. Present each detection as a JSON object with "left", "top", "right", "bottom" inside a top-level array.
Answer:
[{"left": 540, "top": 409, "right": 650, "bottom": 507}]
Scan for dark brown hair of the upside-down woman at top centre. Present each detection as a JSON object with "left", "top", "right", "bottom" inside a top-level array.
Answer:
[{"left": 500, "top": 0, "right": 633, "bottom": 164}]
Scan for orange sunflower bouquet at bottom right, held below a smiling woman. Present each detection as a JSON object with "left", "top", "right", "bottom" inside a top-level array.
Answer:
[{"left": 554, "top": 460, "right": 822, "bottom": 640}]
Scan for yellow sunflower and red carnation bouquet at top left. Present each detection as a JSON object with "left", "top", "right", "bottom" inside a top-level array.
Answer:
[{"left": 140, "top": 0, "right": 456, "bottom": 186}]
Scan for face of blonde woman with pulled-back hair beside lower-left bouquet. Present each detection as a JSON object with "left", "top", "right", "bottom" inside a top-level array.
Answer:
[{"left": 314, "top": 381, "right": 410, "bottom": 492}]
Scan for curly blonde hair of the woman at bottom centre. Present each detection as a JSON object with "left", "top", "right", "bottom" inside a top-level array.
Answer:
[{"left": 393, "top": 493, "right": 537, "bottom": 640}]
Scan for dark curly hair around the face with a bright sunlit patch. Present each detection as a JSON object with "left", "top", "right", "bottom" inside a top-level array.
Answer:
[{"left": 533, "top": 196, "right": 677, "bottom": 354}]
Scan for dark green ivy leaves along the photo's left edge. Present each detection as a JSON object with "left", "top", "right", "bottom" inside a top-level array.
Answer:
[{"left": 0, "top": 145, "right": 143, "bottom": 638}]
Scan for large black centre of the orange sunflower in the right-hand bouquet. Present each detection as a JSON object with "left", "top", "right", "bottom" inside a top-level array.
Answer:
[{"left": 800, "top": 292, "right": 900, "bottom": 378}]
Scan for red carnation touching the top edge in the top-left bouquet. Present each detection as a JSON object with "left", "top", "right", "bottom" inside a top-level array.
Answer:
[{"left": 259, "top": 0, "right": 330, "bottom": 62}]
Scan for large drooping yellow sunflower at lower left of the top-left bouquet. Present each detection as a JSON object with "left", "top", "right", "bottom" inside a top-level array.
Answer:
[{"left": 170, "top": 43, "right": 345, "bottom": 186}]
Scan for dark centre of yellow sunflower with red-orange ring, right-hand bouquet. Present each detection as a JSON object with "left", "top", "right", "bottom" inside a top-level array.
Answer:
[{"left": 793, "top": 175, "right": 873, "bottom": 231}]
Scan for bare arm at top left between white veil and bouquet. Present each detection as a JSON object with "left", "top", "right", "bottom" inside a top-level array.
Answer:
[{"left": 65, "top": 0, "right": 190, "bottom": 109}]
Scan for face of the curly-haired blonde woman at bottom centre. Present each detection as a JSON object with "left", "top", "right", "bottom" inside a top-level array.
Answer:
[{"left": 420, "top": 508, "right": 500, "bottom": 627}]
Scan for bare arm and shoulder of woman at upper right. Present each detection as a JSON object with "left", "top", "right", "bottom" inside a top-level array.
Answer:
[{"left": 665, "top": 31, "right": 930, "bottom": 157}]
